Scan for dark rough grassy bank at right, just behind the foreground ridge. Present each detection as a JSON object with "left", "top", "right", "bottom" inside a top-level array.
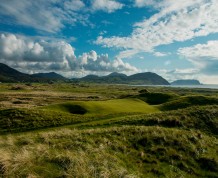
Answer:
[{"left": 79, "top": 105, "right": 218, "bottom": 136}]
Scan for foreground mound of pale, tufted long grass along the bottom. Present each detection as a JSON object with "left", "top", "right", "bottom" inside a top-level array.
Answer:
[{"left": 0, "top": 126, "right": 218, "bottom": 177}]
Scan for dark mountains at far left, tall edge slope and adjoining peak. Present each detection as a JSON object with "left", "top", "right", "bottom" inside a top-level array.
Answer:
[{"left": 0, "top": 63, "right": 69, "bottom": 82}]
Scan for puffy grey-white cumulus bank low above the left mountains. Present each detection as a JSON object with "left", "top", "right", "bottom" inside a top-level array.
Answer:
[{"left": 0, "top": 34, "right": 137, "bottom": 76}]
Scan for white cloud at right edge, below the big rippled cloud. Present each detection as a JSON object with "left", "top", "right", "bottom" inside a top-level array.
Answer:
[{"left": 178, "top": 41, "right": 218, "bottom": 75}]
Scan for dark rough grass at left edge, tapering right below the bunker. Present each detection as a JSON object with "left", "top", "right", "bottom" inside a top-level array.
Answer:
[{"left": 0, "top": 109, "right": 94, "bottom": 133}]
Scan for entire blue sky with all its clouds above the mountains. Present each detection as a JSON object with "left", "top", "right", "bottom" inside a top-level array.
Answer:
[{"left": 0, "top": 0, "right": 218, "bottom": 84}]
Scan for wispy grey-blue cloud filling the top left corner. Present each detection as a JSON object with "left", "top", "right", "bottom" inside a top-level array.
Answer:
[{"left": 0, "top": 0, "right": 88, "bottom": 33}]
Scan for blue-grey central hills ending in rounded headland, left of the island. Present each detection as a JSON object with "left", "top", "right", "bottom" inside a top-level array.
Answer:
[{"left": 74, "top": 72, "right": 169, "bottom": 85}]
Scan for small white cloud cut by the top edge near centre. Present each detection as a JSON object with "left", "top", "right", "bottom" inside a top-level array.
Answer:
[{"left": 92, "top": 0, "right": 124, "bottom": 13}]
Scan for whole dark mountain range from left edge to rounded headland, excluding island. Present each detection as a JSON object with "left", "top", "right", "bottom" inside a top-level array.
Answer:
[{"left": 0, "top": 63, "right": 170, "bottom": 85}]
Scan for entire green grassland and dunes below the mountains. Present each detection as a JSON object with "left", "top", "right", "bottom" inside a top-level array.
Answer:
[{"left": 0, "top": 82, "right": 218, "bottom": 178}]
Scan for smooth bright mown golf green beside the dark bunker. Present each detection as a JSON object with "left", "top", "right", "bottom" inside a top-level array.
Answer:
[{"left": 45, "top": 98, "right": 159, "bottom": 115}]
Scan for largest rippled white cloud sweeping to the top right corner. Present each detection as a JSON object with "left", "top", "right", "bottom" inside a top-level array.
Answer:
[{"left": 95, "top": 0, "right": 218, "bottom": 58}]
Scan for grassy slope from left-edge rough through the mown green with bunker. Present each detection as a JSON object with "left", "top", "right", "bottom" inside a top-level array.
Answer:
[{"left": 0, "top": 99, "right": 159, "bottom": 133}]
